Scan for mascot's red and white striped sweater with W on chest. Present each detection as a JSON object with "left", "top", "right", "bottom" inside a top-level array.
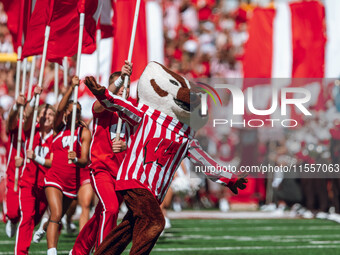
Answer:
[{"left": 96, "top": 90, "right": 232, "bottom": 203}]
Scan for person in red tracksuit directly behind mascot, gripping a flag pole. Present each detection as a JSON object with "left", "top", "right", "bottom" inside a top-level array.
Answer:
[{"left": 70, "top": 62, "right": 132, "bottom": 255}]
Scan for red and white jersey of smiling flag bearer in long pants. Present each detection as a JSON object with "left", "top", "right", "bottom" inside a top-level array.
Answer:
[{"left": 20, "top": 124, "right": 53, "bottom": 187}]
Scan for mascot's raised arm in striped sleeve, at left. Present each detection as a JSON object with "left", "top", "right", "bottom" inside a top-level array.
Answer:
[{"left": 85, "top": 76, "right": 143, "bottom": 126}]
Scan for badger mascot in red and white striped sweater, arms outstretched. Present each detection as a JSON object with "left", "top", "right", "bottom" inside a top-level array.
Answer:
[{"left": 85, "top": 62, "right": 247, "bottom": 255}]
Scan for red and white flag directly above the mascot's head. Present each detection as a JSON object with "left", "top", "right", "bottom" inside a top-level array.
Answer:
[{"left": 111, "top": 0, "right": 164, "bottom": 97}]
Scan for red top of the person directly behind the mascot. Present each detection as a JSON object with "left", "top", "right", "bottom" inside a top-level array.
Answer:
[{"left": 89, "top": 104, "right": 125, "bottom": 177}]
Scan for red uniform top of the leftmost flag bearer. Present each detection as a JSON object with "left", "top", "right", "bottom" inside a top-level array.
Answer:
[{"left": 6, "top": 127, "right": 25, "bottom": 185}]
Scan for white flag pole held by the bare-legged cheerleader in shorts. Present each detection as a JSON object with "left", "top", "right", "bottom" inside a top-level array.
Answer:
[{"left": 68, "top": 13, "right": 85, "bottom": 164}]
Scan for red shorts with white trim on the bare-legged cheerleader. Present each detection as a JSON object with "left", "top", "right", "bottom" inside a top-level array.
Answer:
[{"left": 45, "top": 168, "right": 81, "bottom": 199}]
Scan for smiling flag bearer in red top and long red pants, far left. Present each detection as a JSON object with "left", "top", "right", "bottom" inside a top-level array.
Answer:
[{"left": 14, "top": 104, "right": 55, "bottom": 254}]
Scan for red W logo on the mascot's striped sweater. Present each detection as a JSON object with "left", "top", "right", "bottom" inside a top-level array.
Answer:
[{"left": 144, "top": 137, "right": 181, "bottom": 167}]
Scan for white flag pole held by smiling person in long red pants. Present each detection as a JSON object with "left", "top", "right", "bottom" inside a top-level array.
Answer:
[{"left": 27, "top": 26, "right": 50, "bottom": 163}]
